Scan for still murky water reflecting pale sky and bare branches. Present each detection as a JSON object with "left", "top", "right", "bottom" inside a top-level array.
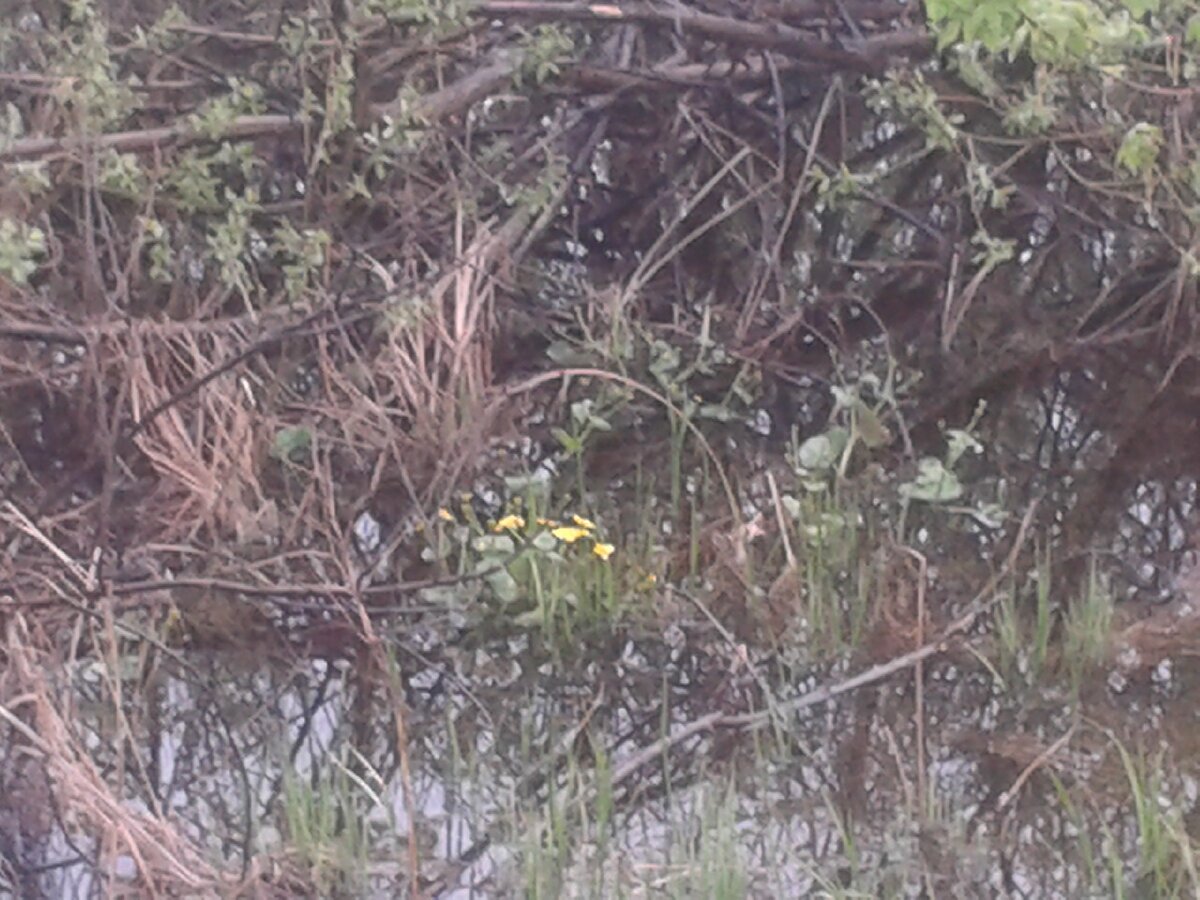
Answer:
[{"left": 17, "top": 340, "right": 1200, "bottom": 898}]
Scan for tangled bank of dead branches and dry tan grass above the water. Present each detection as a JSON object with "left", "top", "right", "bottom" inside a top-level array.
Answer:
[{"left": 0, "top": 0, "right": 1196, "bottom": 896}]
